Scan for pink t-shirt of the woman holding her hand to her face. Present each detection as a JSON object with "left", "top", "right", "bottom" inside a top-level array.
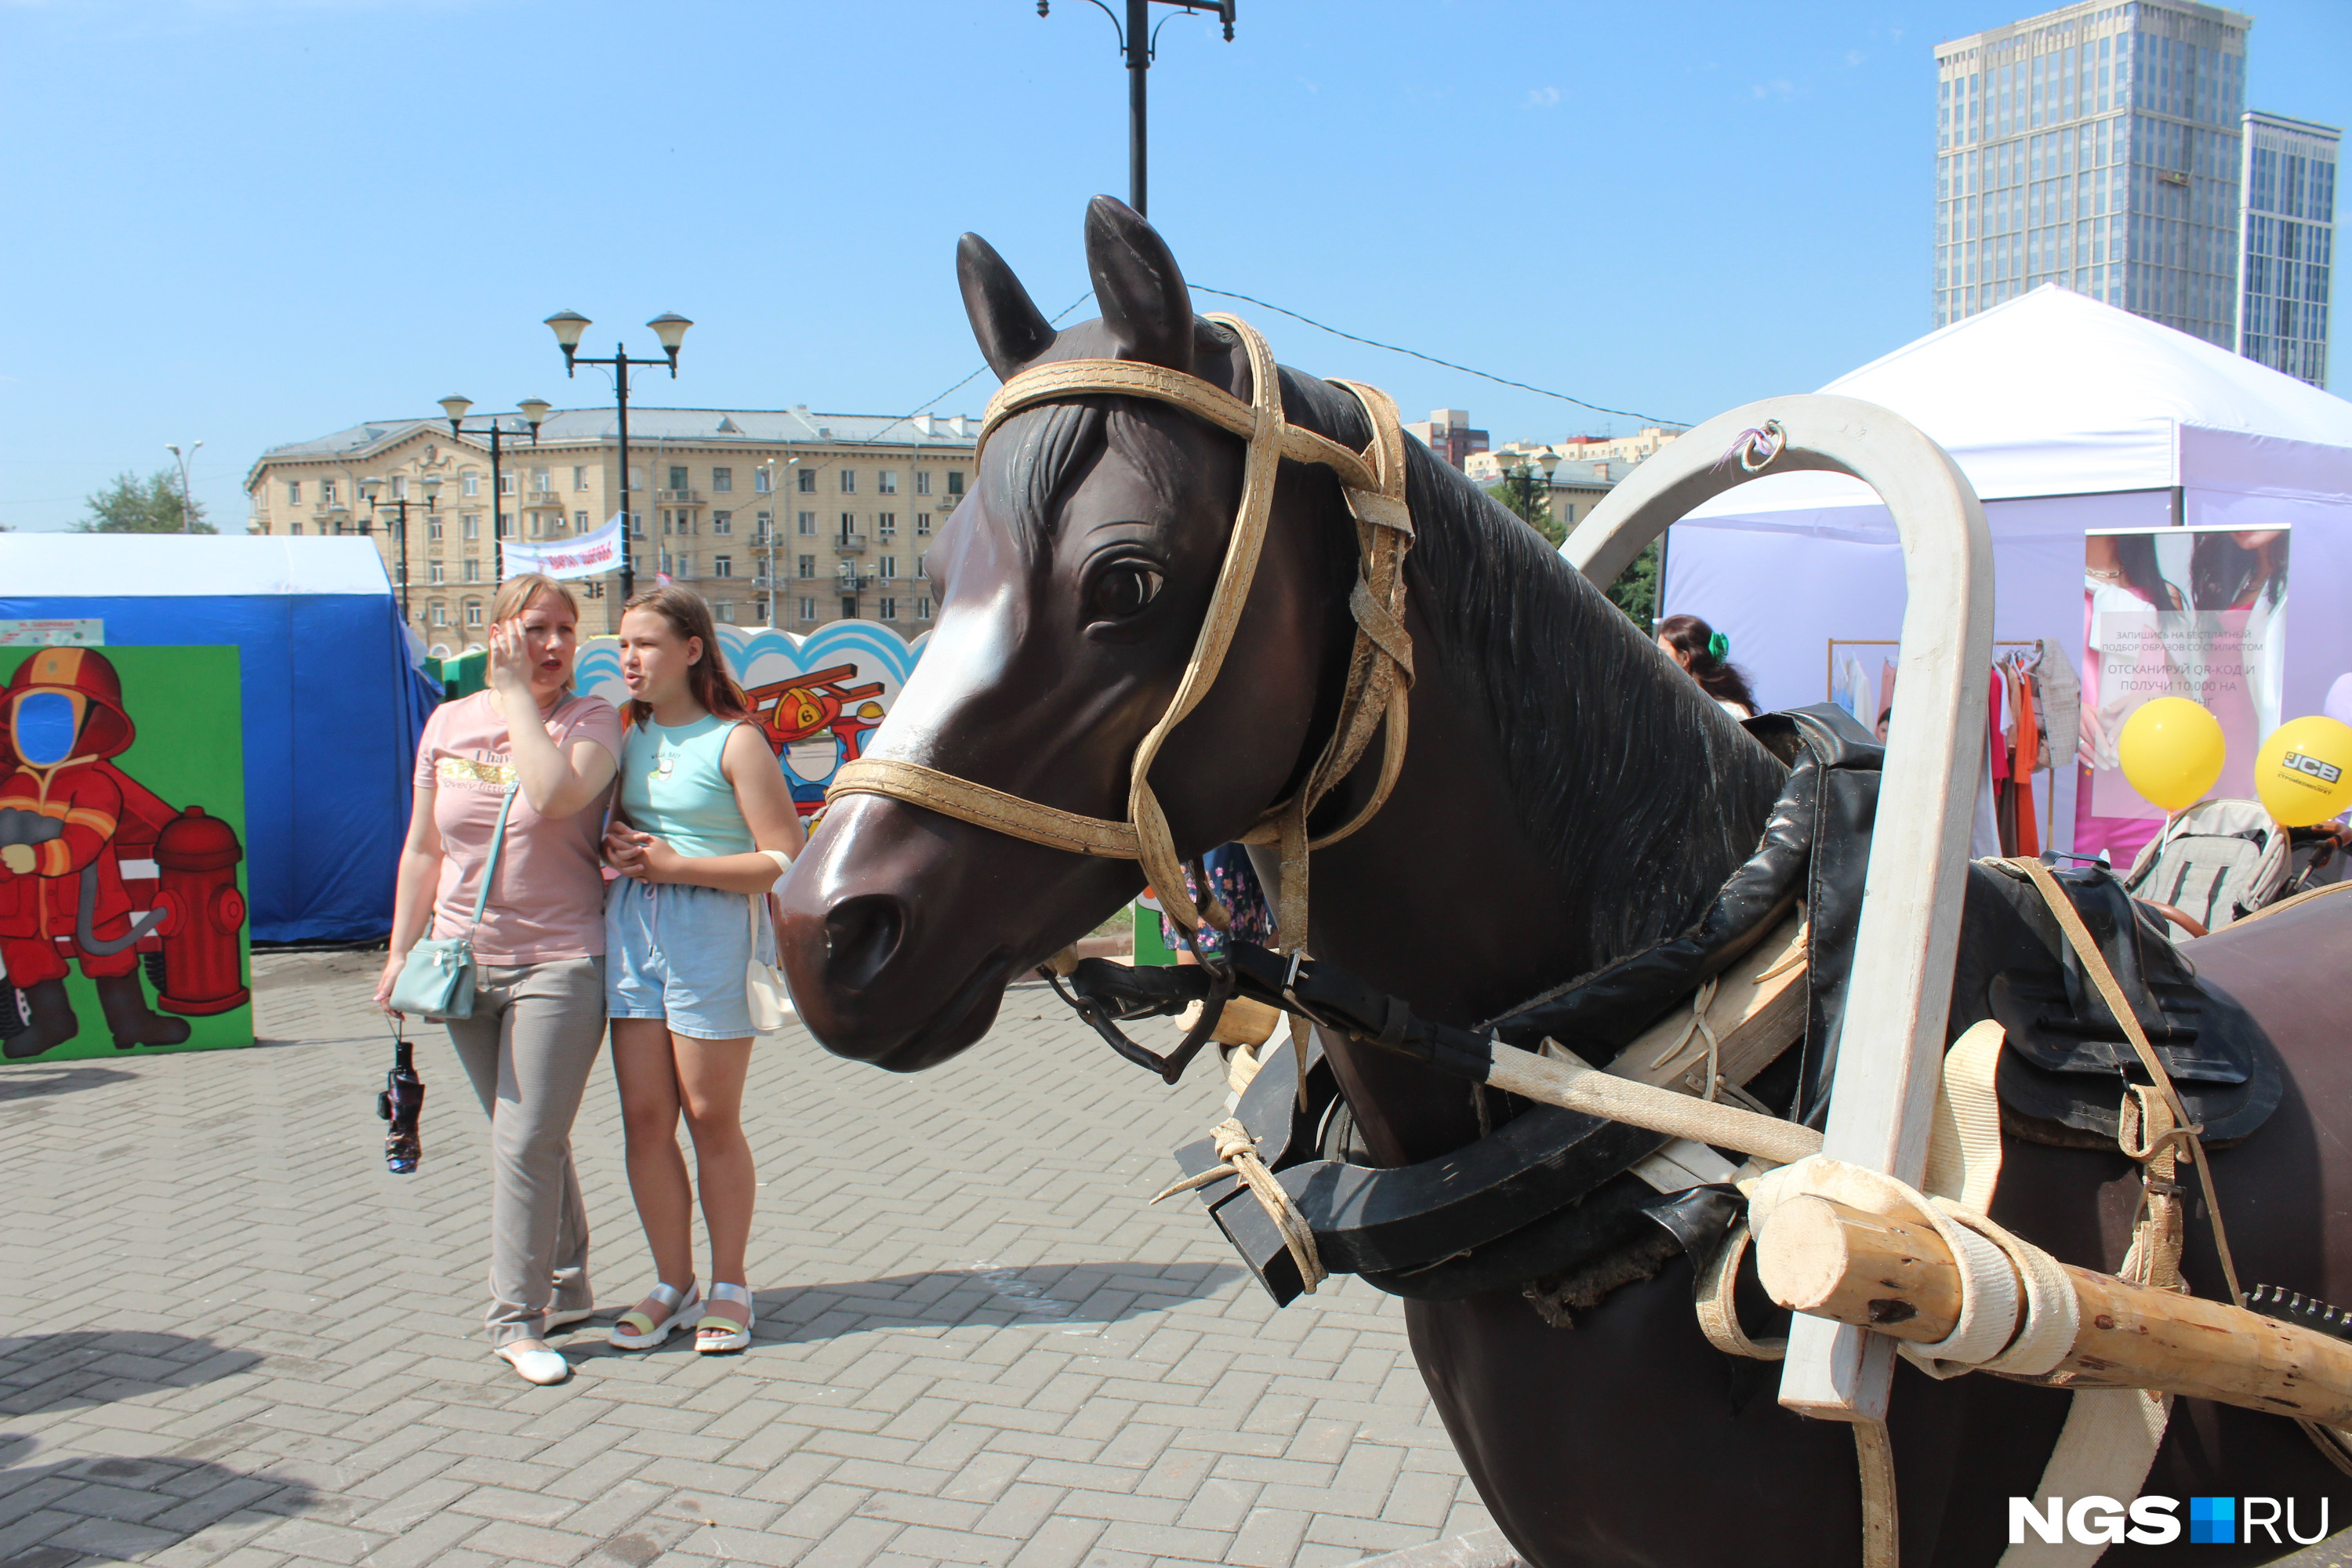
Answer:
[{"left": 416, "top": 691, "right": 621, "bottom": 964}]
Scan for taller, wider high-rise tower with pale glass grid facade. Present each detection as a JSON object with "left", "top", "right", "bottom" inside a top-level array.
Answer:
[{"left": 1936, "top": 0, "right": 2253, "bottom": 348}]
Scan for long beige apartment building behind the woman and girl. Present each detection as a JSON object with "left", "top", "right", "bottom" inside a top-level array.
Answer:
[{"left": 245, "top": 407, "right": 978, "bottom": 654}]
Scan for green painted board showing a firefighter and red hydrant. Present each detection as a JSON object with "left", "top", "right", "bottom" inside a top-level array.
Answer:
[{"left": 0, "top": 647, "right": 254, "bottom": 1062}]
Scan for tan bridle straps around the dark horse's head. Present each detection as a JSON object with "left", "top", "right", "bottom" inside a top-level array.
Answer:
[{"left": 826, "top": 315, "right": 1414, "bottom": 949}]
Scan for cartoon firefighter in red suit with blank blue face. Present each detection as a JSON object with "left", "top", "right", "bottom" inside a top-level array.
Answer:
[{"left": 0, "top": 649, "right": 198, "bottom": 1058}]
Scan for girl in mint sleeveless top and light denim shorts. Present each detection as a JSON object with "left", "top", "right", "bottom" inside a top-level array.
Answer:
[{"left": 604, "top": 586, "right": 802, "bottom": 1352}]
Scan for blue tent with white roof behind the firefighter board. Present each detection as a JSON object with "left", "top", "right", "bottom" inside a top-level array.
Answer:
[{"left": 0, "top": 534, "right": 440, "bottom": 942}]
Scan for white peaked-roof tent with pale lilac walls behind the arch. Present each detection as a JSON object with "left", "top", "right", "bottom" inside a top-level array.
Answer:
[{"left": 1663, "top": 285, "right": 2352, "bottom": 846}]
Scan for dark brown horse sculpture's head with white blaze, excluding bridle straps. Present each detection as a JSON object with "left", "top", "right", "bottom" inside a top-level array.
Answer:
[{"left": 783, "top": 198, "right": 1367, "bottom": 1072}]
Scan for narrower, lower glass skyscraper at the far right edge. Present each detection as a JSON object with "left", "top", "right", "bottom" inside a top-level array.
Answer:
[{"left": 2237, "top": 111, "right": 2343, "bottom": 386}]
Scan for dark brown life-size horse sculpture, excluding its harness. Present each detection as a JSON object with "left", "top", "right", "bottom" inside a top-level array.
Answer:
[{"left": 783, "top": 198, "right": 2352, "bottom": 1568}]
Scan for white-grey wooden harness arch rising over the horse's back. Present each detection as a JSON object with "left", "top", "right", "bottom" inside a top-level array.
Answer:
[{"left": 1562, "top": 395, "right": 1992, "bottom": 1420}]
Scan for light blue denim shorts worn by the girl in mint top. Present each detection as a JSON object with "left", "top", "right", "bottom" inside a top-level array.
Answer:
[{"left": 604, "top": 877, "right": 776, "bottom": 1039}]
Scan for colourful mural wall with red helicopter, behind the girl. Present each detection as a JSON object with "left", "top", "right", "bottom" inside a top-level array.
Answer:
[{"left": 576, "top": 621, "right": 929, "bottom": 818}]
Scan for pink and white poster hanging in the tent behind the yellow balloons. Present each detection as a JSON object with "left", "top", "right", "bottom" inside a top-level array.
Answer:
[{"left": 2074, "top": 529, "right": 2288, "bottom": 865}]
